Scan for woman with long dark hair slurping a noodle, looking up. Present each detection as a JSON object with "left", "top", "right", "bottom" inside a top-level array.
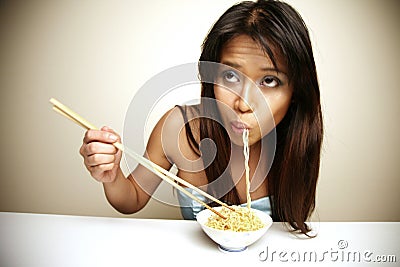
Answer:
[{"left": 80, "top": 1, "right": 323, "bottom": 234}]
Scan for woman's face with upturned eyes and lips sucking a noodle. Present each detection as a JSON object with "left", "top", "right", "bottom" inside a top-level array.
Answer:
[{"left": 214, "top": 35, "right": 293, "bottom": 148}]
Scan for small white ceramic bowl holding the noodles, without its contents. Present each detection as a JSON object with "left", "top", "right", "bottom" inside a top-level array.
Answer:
[{"left": 196, "top": 207, "right": 272, "bottom": 252}]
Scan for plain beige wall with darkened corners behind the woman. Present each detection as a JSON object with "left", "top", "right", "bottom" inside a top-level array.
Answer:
[{"left": 0, "top": 0, "right": 400, "bottom": 221}]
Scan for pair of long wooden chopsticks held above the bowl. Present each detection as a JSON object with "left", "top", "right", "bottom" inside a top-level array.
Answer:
[{"left": 50, "top": 98, "right": 231, "bottom": 219}]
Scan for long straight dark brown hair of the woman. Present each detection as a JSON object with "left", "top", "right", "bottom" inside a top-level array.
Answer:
[{"left": 183, "top": 0, "right": 323, "bottom": 234}]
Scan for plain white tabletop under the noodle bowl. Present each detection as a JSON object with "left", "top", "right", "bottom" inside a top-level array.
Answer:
[{"left": 0, "top": 212, "right": 400, "bottom": 267}]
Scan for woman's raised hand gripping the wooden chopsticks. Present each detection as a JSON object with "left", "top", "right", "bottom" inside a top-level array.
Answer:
[{"left": 79, "top": 126, "right": 122, "bottom": 183}]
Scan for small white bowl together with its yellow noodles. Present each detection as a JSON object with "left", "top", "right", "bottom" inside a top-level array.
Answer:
[{"left": 196, "top": 206, "right": 272, "bottom": 252}]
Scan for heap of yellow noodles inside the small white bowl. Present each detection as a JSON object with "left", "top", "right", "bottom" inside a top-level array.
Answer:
[{"left": 206, "top": 206, "right": 265, "bottom": 232}]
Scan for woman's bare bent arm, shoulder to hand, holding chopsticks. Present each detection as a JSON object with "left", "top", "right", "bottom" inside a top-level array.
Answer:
[{"left": 80, "top": 110, "right": 183, "bottom": 214}]
